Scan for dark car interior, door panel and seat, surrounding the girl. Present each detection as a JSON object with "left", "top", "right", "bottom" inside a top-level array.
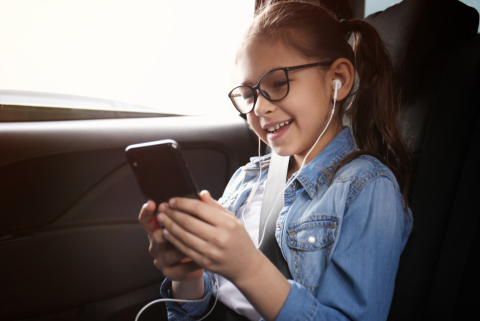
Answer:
[{"left": 0, "top": 0, "right": 480, "bottom": 321}]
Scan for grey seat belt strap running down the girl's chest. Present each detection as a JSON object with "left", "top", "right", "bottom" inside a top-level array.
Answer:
[{"left": 258, "top": 152, "right": 292, "bottom": 279}]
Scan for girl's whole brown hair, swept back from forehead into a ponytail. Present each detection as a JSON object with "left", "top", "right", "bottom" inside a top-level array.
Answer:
[{"left": 237, "top": 1, "right": 411, "bottom": 209}]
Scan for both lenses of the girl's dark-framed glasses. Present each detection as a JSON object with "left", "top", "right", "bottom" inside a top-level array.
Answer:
[{"left": 230, "top": 70, "right": 288, "bottom": 114}]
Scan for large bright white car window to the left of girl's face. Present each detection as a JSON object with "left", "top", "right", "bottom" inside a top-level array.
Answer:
[{"left": 0, "top": 0, "right": 255, "bottom": 115}]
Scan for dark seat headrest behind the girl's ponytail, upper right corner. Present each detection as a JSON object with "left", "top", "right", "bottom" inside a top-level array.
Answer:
[{"left": 365, "top": 0, "right": 478, "bottom": 101}]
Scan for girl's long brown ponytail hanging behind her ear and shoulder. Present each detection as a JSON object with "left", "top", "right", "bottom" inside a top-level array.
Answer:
[{"left": 337, "top": 19, "right": 411, "bottom": 208}]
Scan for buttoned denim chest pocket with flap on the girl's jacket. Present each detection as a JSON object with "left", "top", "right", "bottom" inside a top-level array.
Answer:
[{"left": 287, "top": 215, "right": 339, "bottom": 294}]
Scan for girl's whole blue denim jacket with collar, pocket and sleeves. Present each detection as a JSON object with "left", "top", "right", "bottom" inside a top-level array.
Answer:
[{"left": 161, "top": 127, "right": 412, "bottom": 321}]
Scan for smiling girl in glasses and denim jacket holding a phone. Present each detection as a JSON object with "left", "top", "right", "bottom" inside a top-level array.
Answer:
[{"left": 139, "top": 1, "right": 411, "bottom": 320}]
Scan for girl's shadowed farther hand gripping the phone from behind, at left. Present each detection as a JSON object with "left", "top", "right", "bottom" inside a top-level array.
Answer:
[{"left": 138, "top": 201, "right": 203, "bottom": 281}]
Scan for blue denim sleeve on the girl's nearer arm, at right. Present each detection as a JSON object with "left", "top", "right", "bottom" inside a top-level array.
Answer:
[{"left": 276, "top": 176, "right": 411, "bottom": 321}]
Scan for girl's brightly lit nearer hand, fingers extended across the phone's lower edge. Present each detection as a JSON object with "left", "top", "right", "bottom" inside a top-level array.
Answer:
[{"left": 158, "top": 191, "right": 264, "bottom": 283}]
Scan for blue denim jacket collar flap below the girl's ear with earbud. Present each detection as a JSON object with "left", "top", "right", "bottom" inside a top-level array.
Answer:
[{"left": 289, "top": 127, "right": 355, "bottom": 198}]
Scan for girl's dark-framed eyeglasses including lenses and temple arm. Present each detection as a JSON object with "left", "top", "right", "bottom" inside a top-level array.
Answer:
[{"left": 228, "top": 61, "right": 333, "bottom": 114}]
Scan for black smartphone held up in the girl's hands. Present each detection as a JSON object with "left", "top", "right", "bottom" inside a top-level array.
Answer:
[{"left": 125, "top": 139, "right": 200, "bottom": 228}]
